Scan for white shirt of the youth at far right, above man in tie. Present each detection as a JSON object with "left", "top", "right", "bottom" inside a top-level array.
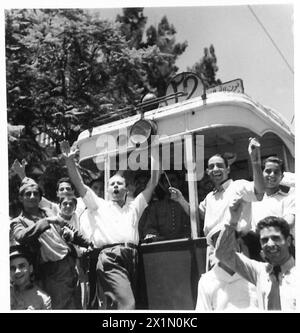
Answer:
[{"left": 252, "top": 190, "right": 295, "bottom": 236}]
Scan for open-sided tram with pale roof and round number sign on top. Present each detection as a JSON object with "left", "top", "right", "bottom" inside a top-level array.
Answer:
[{"left": 77, "top": 73, "right": 295, "bottom": 310}]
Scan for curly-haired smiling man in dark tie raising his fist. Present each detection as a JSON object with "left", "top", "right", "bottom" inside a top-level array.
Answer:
[{"left": 215, "top": 199, "right": 298, "bottom": 311}]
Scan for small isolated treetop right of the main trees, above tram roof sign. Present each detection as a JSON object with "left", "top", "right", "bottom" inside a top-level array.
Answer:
[{"left": 188, "top": 45, "right": 222, "bottom": 88}]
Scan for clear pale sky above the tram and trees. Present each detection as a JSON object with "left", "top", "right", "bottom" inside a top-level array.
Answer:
[{"left": 93, "top": 4, "right": 294, "bottom": 126}]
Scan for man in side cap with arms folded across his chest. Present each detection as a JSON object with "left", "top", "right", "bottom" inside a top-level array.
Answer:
[{"left": 11, "top": 178, "right": 89, "bottom": 309}]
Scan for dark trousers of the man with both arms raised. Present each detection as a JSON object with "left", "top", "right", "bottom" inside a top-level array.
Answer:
[{"left": 96, "top": 245, "right": 138, "bottom": 310}]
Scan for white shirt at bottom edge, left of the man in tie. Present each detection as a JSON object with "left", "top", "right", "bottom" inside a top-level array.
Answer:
[{"left": 196, "top": 264, "right": 258, "bottom": 312}]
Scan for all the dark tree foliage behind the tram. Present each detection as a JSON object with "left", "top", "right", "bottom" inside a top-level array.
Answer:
[{"left": 5, "top": 8, "right": 221, "bottom": 210}]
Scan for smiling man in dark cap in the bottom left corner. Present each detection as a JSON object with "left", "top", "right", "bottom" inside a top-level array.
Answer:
[{"left": 10, "top": 246, "right": 51, "bottom": 310}]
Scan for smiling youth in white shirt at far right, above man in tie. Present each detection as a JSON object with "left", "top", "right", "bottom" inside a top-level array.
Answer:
[{"left": 252, "top": 156, "right": 295, "bottom": 237}]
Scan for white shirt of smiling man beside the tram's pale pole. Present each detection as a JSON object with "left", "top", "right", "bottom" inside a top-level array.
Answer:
[{"left": 199, "top": 179, "right": 257, "bottom": 236}]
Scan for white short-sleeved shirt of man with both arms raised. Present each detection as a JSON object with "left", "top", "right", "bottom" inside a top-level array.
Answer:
[{"left": 80, "top": 188, "right": 148, "bottom": 248}]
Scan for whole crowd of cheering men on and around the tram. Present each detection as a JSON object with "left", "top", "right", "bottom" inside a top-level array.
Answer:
[{"left": 10, "top": 139, "right": 296, "bottom": 312}]
